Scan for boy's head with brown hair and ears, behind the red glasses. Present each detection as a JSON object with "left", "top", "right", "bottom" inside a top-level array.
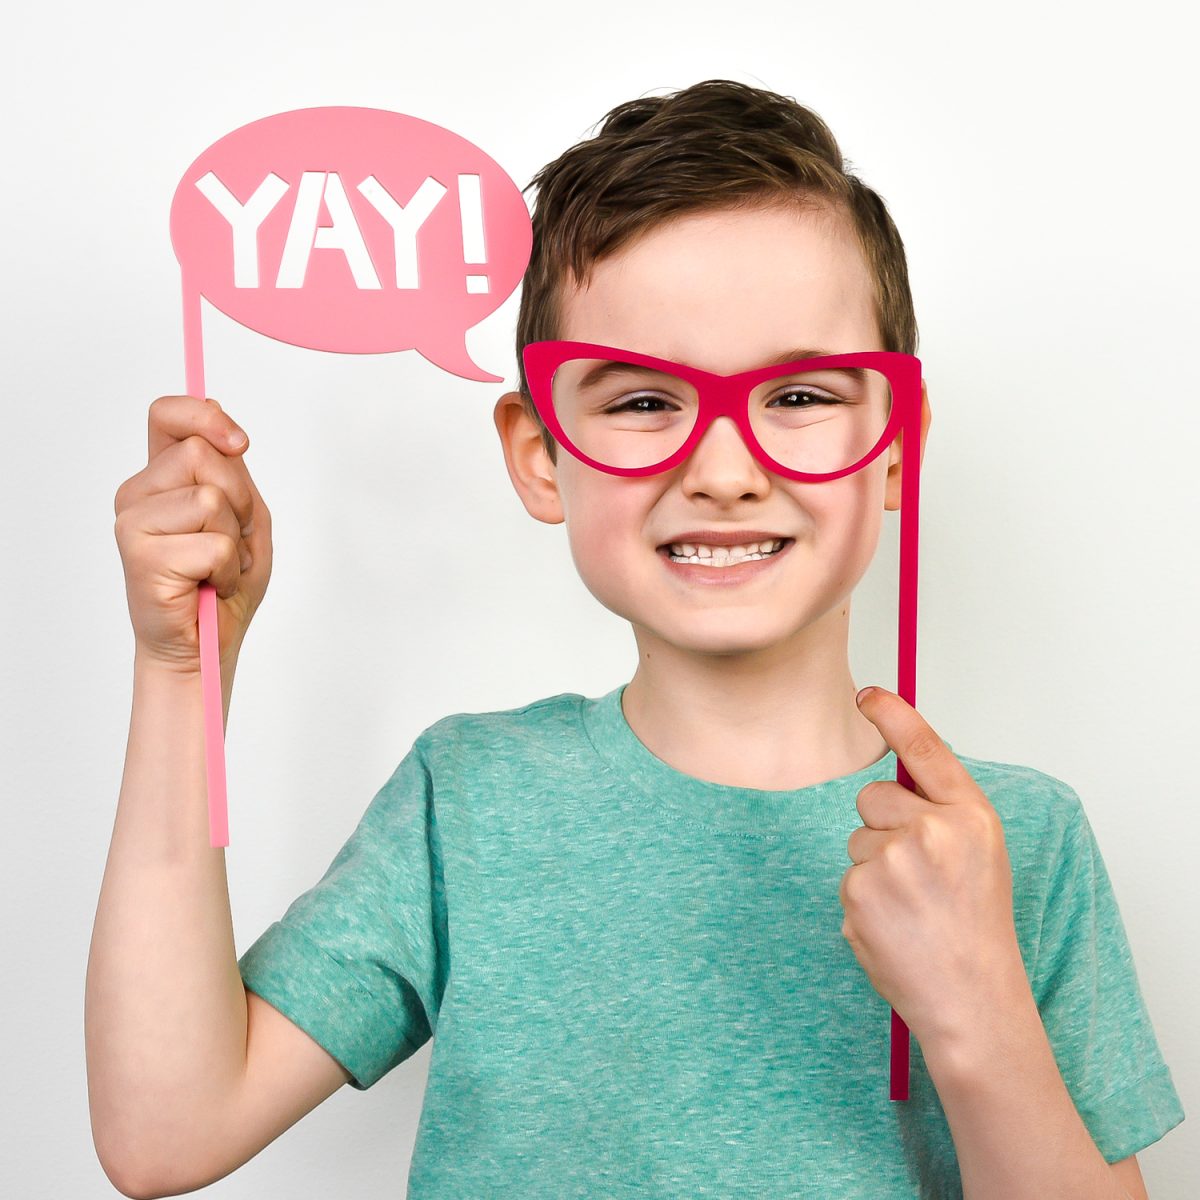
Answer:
[{"left": 496, "top": 79, "right": 929, "bottom": 667}]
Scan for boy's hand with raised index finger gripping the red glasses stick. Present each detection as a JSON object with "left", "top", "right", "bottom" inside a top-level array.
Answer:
[{"left": 838, "top": 688, "right": 1028, "bottom": 1050}]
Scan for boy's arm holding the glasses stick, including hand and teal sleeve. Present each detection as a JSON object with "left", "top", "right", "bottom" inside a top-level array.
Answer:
[{"left": 841, "top": 689, "right": 1183, "bottom": 1200}]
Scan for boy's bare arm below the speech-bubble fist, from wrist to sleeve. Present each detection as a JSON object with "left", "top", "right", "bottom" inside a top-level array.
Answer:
[{"left": 84, "top": 659, "right": 347, "bottom": 1196}]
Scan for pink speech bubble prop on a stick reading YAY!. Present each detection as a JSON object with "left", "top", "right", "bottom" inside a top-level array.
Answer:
[{"left": 170, "top": 107, "right": 533, "bottom": 847}]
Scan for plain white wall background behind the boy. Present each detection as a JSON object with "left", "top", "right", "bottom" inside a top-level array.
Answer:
[{"left": 0, "top": 0, "right": 1200, "bottom": 1200}]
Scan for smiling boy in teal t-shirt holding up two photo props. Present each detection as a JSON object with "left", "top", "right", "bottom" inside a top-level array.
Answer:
[{"left": 88, "top": 80, "right": 1183, "bottom": 1200}]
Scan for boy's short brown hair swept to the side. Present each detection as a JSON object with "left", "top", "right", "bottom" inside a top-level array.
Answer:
[{"left": 516, "top": 79, "right": 917, "bottom": 462}]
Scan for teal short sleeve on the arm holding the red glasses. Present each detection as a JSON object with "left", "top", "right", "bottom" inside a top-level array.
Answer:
[{"left": 1031, "top": 792, "right": 1184, "bottom": 1163}]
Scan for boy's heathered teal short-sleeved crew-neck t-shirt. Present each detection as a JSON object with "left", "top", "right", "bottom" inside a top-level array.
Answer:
[{"left": 239, "top": 685, "right": 1184, "bottom": 1200}]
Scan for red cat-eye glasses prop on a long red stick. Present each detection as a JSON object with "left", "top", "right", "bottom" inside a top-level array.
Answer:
[{"left": 522, "top": 342, "right": 922, "bottom": 1100}]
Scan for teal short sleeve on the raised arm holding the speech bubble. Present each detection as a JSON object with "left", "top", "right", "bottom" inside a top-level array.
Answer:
[{"left": 238, "top": 738, "right": 448, "bottom": 1091}]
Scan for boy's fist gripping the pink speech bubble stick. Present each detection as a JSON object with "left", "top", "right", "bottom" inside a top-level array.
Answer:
[{"left": 114, "top": 396, "right": 272, "bottom": 673}]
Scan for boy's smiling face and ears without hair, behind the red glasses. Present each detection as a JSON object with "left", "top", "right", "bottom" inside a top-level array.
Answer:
[{"left": 496, "top": 206, "right": 929, "bottom": 654}]
